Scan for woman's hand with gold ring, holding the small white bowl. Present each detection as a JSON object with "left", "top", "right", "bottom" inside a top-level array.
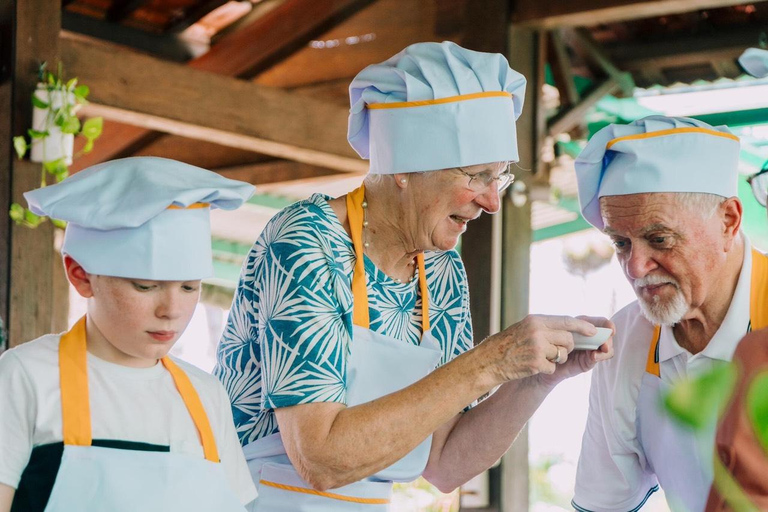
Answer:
[{"left": 478, "top": 315, "right": 600, "bottom": 384}]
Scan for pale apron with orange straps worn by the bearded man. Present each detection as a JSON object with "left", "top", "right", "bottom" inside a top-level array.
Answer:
[{"left": 636, "top": 249, "right": 768, "bottom": 512}]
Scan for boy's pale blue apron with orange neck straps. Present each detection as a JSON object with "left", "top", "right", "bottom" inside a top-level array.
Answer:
[{"left": 39, "top": 317, "right": 245, "bottom": 512}]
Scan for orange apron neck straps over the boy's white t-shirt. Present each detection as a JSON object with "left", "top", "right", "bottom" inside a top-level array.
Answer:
[{"left": 59, "top": 317, "right": 219, "bottom": 462}]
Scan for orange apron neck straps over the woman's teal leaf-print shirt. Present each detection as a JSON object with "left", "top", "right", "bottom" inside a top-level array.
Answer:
[{"left": 347, "top": 185, "right": 429, "bottom": 333}]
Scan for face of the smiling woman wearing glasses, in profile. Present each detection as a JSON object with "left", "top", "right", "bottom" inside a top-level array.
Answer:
[{"left": 408, "top": 162, "right": 507, "bottom": 251}]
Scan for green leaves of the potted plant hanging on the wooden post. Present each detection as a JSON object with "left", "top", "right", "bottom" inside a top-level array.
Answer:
[{"left": 8, "top": 63, "right": 104, "bottom": 228}]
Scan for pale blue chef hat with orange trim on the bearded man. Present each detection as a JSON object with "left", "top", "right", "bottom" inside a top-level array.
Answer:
[{"left": 576, "top": 116, "right": 739, "bottom": 229}]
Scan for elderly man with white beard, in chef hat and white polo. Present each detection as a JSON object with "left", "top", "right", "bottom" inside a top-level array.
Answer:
[{"left": 573, "top": 116, "right": 766, "bottom": 512}]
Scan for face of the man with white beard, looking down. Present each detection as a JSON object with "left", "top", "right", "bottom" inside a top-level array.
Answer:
[{"left": 600, "top": 193, "right": 728, "bottom": 325}]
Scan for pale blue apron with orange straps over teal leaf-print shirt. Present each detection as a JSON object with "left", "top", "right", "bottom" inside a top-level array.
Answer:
[{"left": 243, "top": 186, "right": 442, "bottom": 512}]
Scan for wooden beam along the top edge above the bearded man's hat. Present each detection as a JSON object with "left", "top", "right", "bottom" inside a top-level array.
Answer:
[{"left": 511, "top": 0, "right": 755, "bottom": 28}]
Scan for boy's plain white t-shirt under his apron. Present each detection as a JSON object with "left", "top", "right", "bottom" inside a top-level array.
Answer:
[{"left": 0, "top": 334, "right": 256, "bottom": 504}]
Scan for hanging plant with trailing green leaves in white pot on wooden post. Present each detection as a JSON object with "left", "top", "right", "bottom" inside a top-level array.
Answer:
[{"left": 9, "top": 63, "right": 104, "bottom": 228}]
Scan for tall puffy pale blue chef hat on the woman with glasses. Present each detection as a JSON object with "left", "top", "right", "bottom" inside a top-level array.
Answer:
[{"left": 347, "top": 42, "right": 525, "bottom": 174}]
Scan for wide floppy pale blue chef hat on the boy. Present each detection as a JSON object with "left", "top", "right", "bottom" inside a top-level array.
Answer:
[{"left": 24, "top": 157, "right": 254, "bottom": 281}]
